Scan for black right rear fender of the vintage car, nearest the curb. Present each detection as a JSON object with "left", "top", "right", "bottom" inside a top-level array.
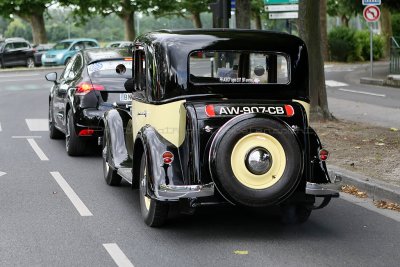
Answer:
[{"left": 307, "top": 127, "right": 331, "bottom": 183}]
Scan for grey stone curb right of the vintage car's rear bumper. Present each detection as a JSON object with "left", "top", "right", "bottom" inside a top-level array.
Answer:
[{"left": 328, "top": 165, "right": 400, "bottom": 203}]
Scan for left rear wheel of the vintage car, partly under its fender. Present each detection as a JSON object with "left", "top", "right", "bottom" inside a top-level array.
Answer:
[{"left": 139, "top": 153, "right": 169, "bottom": 227}]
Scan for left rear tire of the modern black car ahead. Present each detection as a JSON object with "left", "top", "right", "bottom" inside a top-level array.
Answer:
[{"left": 65, "top": 110, "right": 86, "bottom": 156}]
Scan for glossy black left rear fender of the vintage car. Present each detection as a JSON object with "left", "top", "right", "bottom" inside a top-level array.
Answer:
[{"left": 133, "top": 126, "right": 188, "bottom": 201}]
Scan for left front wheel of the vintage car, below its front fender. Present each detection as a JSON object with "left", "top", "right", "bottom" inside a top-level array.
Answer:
[{"left": 102, "top": 128, "right": 122, "bottom": 186}]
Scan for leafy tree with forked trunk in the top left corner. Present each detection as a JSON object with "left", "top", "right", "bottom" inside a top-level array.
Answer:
[{"left": 0, "top": 0, "right": 54, "bottom": 44}]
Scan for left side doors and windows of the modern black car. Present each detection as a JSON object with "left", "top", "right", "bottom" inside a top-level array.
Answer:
[{"left": 53, "top": 54, "right": 82, "bottom": 131}]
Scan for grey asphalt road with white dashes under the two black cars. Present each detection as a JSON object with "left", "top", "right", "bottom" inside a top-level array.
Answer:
[{"left": 0, "top": 68, "right": 400, "bottom": 266}]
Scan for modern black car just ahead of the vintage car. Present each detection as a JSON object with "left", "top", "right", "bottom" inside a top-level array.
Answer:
[{"left": 46, "top": 48, "right": 132, "bottom": 156}]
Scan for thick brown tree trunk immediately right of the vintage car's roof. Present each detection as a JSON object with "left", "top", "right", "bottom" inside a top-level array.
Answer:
[{"left": 298, "top": 0, "right": 332, "bottom": 119}]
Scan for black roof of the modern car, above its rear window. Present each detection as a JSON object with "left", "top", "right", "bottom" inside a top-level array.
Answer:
[{"left": 83, "top": 48, "right": 132, "bottom": 64}]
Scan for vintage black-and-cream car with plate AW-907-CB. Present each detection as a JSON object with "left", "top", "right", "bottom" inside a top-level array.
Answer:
[{"left": 102, "top": 30, "right": 339, "bottom": 226}]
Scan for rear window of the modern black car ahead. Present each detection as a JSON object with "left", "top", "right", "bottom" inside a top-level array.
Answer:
[{"left": 88, "top": 59, "right": 132, "bottom": 79}]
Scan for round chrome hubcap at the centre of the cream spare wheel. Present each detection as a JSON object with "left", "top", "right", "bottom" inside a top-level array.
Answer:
[{"left": 245, "top": 147, "right": 272, "bottom": 175}]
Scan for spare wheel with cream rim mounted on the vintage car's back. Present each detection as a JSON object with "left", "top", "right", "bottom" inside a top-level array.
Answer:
[{"left": 209, "top": 114, "right": 303, "bottom": 207}]
